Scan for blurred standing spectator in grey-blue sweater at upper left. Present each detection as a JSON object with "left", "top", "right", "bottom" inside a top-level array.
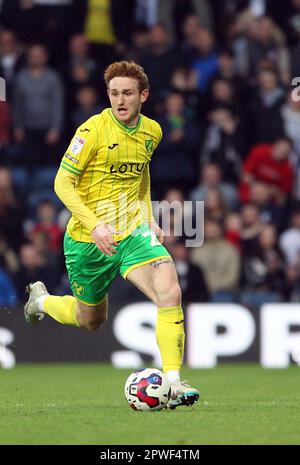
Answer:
[{"left": 14, "top": 45, "right": 63, "bottom": 166}]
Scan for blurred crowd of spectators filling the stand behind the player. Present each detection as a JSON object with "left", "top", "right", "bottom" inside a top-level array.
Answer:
[{"left": 0, "top": 0, "right": 300, "bottom": 307}]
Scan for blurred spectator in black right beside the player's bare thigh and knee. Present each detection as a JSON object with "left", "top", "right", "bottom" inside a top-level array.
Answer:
[{"left": 169, "top": 240, "right": 210, "bottom": 304}]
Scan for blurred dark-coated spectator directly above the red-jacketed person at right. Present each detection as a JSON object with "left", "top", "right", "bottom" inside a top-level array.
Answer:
[{"left": 249, "top": 70, "right": 285, "bottom": 144}]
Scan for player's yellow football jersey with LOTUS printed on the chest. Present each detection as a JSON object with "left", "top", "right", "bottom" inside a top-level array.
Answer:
[{"left": 60, "top": 108, "right": 162, "bottom": 242}]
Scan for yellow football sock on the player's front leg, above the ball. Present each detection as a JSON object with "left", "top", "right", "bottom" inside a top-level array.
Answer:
[{"left": 156, "top": 305, "right": 184, "bottom": 373}]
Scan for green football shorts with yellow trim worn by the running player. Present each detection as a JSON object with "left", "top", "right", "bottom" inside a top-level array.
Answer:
[{"left": 64, "top": 223, "right": 170, "bottom": 305}]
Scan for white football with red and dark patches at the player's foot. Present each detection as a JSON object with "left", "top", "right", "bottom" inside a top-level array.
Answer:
[{"left": 125, "top": 368, "right": 171, "bottom": 412}]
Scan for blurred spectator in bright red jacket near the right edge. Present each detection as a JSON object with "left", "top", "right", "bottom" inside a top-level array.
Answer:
[{"left": 240, "top": 139, "right": 294, "bottom": 202}]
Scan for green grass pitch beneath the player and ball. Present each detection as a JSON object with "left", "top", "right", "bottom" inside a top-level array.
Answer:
[{"left": 0, "top": 364, "right": 300, "bottom": 445}]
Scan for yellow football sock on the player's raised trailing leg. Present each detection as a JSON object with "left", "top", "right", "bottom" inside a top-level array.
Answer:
[{"left": 43, "top": 295, "right": 79, "bottom": 327}]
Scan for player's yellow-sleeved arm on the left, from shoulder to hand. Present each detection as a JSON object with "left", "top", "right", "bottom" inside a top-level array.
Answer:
[{"left": 54, "top": 120, "right": 117, "bottom": 255}]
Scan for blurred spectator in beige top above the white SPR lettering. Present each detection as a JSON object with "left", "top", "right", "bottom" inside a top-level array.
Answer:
[{"left": 191, "top": 219, "right": 240, "bottom": 302}]
